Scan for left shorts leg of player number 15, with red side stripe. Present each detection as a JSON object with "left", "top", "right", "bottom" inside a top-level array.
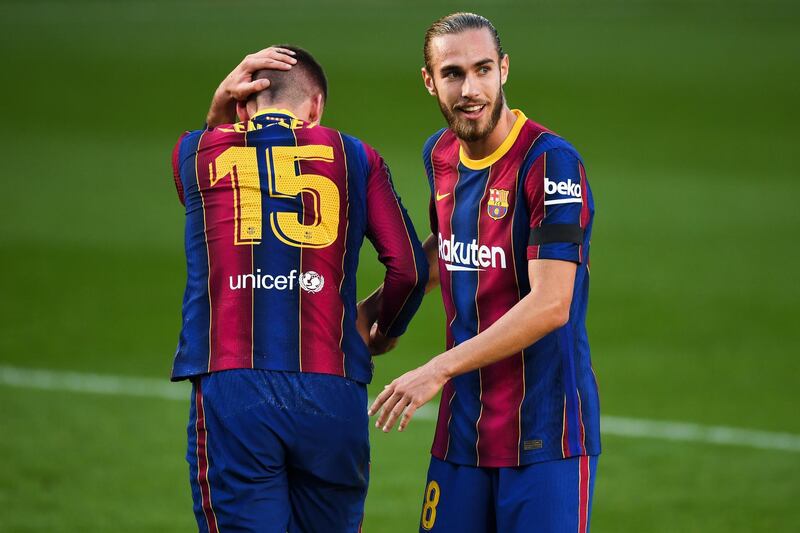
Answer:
[{"left": 186, "top": 370, "right": 289, "bottom": 533}]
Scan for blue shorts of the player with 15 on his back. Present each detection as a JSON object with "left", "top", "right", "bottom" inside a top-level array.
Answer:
[{"left": 186, "top": 369, "right": 369, "bottom": 533}]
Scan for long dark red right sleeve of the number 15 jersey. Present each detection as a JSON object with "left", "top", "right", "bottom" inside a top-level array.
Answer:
[{"left": 364, "top": 139, "right": 428, "bottom": 337}]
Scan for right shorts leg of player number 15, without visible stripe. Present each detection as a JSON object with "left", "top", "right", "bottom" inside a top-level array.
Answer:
[{"left": 287, "top": 374, "right": 369, "bottom": 533}]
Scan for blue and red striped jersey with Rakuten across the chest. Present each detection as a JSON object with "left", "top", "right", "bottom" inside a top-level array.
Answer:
[{"left": 423, "top": 110, "right": 600, "bottom": 467}]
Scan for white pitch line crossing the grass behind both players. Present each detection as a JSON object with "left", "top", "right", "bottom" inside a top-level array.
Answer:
[{"left": 0, "top": 365, "right": 800, "bottom": 452}]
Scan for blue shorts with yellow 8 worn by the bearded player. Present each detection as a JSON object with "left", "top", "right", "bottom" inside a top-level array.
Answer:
[{"left": 419, "top": 456, "right": 597, "bottom": 533}]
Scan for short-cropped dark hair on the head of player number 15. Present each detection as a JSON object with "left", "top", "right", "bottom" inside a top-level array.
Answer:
[{"left": 253, "top": 44, "right": 328, "bottom": 106}]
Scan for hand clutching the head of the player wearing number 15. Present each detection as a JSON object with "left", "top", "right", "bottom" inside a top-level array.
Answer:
[{"left": 206, "top": 47, "right": 297, "bottom": 128}]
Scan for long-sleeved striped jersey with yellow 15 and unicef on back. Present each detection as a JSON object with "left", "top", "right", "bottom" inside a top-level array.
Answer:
[{"left": 172, "top": 109, "right": 428, "bottom": 383}]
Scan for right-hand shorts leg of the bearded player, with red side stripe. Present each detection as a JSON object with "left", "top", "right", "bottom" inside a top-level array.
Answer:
[{"left": 495, "top": 456, "right": 597, "bottom": 533}]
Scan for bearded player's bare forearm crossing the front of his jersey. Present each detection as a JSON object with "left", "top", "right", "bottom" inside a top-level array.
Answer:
[{"left": 430, "top": 292, "right": 569, "bottom": 379}]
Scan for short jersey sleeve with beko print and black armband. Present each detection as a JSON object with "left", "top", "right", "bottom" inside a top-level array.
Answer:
[{"left": 525, "top": 148, "right": 590, "bottom": 264}]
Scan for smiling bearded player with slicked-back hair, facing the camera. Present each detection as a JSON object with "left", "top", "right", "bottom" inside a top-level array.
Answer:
[{"left": 368, "top": 13, "right": 600, "bottom": 533}]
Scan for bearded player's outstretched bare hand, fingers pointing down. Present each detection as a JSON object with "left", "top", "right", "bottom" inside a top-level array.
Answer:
[{"left": 369, "top": 359, "right": 448, "bottom": 433}]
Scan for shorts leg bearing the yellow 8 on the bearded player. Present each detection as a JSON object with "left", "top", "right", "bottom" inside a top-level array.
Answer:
[{"left": 419, "top": 457, "right": 497, "bottom": 533}]
